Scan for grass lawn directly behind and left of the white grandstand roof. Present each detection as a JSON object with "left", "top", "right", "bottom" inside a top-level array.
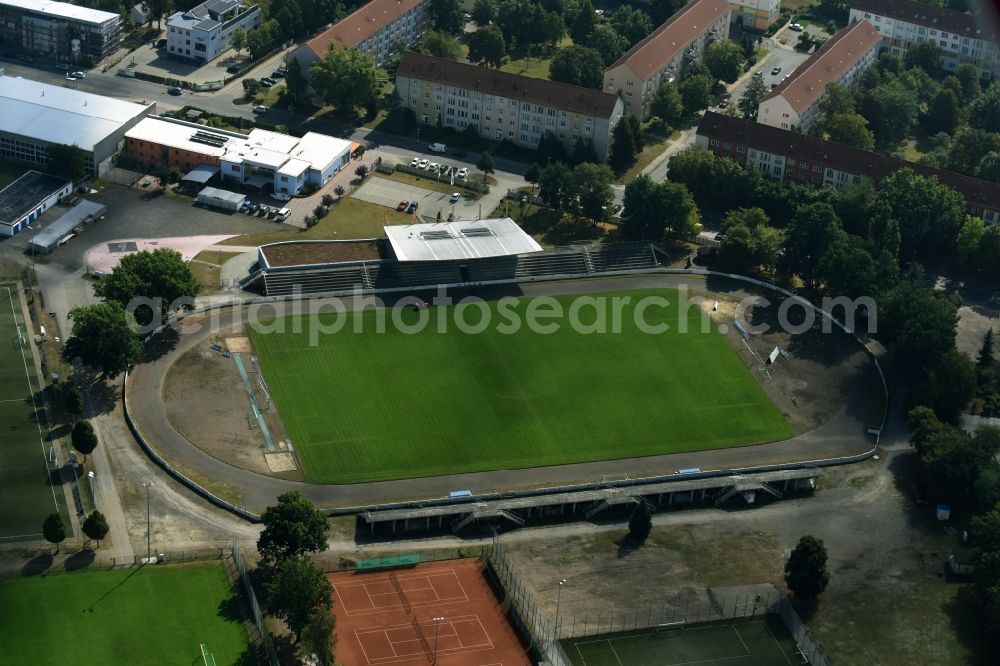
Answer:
[{"left": 220, "top": 196, "right": 402, "bottom": 245}]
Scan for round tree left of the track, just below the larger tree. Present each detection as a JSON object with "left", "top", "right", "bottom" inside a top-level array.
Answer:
[{"left": 62, "top": 303, "right": 142, "bottom": 379}]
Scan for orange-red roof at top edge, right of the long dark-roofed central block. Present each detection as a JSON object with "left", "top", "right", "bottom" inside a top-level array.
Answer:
[{"left": 608, "top": 0, "right": 732, "bottom": 80}]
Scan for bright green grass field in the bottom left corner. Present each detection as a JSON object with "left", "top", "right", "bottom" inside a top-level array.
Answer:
[{"left": 0, "top": 564, "right": 253, "bottom": 666}]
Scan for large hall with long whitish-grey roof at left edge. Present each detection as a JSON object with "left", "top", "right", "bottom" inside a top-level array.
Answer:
[{"left": 0, "top": 75, "right": 156, "bottom": 176}]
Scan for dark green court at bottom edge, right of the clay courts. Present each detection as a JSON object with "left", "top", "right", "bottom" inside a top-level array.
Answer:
[{"left": 561, "top": 615, "right": 802, "bottom": 666}]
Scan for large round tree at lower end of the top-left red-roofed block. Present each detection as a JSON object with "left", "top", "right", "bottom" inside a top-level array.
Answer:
[{"left": 309, "top": 45, "right": 379, "bottom": 109}]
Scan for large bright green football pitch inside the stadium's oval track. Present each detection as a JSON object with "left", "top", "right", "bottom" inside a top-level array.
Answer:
[{"left": 251, "top": 290, "right": 792, "bottom": 483}]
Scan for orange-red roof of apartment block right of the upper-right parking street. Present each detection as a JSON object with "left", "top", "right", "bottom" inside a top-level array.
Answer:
[{"left": 764, "top": 21, "right": 882, "bottom": 113}]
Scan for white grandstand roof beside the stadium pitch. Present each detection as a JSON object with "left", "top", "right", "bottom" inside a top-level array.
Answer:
[{"left": 385, "top": 217, "right": 542, "bottom": 261}]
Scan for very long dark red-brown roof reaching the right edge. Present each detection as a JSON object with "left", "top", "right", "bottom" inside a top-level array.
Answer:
[{"left": 698, "top": 111, "right": 1000, "bottom": 210}]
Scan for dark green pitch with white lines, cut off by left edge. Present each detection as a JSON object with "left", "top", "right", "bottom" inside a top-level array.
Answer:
[{"left": 0, "top": 284, "right": 68, "bottom": 542}]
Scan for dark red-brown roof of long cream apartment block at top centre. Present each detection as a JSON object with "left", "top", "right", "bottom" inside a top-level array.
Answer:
[{"left": 396, "top": 52, "right": 618, "bottom": 118}]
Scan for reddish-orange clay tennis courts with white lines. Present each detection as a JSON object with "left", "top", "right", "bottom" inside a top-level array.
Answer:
[{"left": 327, "top": 559, "right": 531, "bottom": 666}]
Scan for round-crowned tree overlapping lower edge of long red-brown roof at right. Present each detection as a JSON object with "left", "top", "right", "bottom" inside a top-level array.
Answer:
[{"left": 876, "top": 169, "right": 965, "bottom": 259}]
